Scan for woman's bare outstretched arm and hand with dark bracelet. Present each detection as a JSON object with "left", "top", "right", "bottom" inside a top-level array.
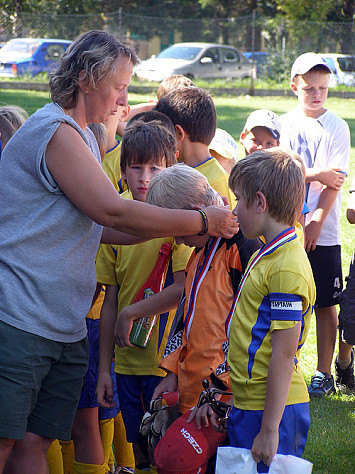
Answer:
[{"left": 46, "top": 123, "right": 238, "bottom": 238}]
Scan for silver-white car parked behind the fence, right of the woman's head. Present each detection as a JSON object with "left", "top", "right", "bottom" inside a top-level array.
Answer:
[{"left": 134, "top": 43, "right": 252, "bottom": 82}]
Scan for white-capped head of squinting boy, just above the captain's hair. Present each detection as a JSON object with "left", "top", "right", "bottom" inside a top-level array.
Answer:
[{"left": 240, "top": 109, "right": 281, "bottom": 155}]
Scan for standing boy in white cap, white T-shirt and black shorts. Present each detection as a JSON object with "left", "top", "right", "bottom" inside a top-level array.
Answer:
[{"left": 281, "top": 53, "right": 350, "bottom": 397}]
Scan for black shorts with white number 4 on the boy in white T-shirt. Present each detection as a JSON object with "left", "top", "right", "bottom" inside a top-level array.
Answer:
[{"left": 308, "top": 245, "right": 343, "bottom": 308}]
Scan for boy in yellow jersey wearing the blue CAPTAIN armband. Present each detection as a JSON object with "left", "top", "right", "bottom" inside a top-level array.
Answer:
[{"left": 204, "top": 149, "right": 315, "bottom": 472}]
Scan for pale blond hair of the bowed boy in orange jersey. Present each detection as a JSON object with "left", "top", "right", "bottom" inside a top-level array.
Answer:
[{"left": 146, "top": 163, "right": 224, "bottom": 209}]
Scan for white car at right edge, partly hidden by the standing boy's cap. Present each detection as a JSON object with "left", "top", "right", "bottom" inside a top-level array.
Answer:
[{"left": 321, "top": 53, "right": 355, "bottom": 87}]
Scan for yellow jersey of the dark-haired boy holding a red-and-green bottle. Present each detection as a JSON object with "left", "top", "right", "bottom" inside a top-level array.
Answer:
[{"left": 96, "top": 191, "right": 192, "bottom": 376}]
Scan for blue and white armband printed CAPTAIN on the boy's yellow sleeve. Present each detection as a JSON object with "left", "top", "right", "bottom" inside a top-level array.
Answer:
[{"left": 270, "top": 293, "right": 302, "bottom": 321}]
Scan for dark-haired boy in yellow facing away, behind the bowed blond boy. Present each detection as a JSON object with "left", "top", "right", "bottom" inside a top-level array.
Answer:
[{"left": 154, "top": 87, "right": 234, "bottom": 206}]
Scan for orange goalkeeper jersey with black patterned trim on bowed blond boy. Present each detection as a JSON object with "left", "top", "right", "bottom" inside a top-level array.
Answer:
[{"left": 160, "top": 232, "right": 260, "bottom": 413}]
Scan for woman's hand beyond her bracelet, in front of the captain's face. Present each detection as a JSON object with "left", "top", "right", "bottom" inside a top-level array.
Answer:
[{"left": 203, "top": 206, "right": 239, "bottom": 239}]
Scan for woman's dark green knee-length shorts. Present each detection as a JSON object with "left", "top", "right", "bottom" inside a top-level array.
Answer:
[{"left": 0, "top": 321, "right": 88, "bottom": 440}]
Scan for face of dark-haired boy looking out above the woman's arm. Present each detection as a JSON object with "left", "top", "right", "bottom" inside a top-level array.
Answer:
[{"left": 122, "top": 160, "right": 166, "bottom": 202}]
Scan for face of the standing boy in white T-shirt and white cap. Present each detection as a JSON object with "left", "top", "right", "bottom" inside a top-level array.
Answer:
[{"left": 291, "top": 71, "right": 329, "bottom": 118}]
